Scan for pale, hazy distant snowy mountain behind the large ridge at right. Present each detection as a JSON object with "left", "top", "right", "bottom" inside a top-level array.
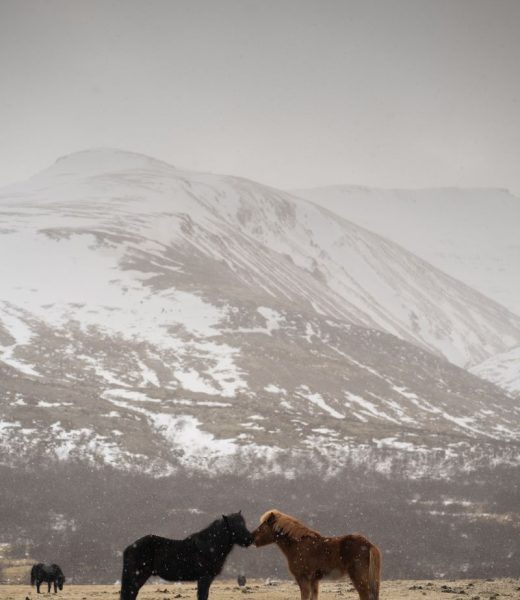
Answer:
[{"left": 295, "top": 186, "right": 520, "bottom": 314}]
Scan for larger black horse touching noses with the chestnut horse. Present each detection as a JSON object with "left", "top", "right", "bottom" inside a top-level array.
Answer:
[{"left": 121, "top": 512, "right": 253, "bottom": 600}]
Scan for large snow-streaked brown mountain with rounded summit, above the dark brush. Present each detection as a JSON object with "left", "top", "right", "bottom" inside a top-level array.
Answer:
[{"left": 0, "top": 150, "right": 520, "bottom": 475}]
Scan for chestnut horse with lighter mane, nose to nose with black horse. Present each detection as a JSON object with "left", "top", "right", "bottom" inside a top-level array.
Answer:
[{"left": 252, "top": 510, "right": 381, "bottom": 600}]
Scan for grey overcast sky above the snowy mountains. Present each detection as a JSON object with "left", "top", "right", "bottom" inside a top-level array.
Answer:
[{"left": 0, "top": 0, "right": 520, "bottom": 192}]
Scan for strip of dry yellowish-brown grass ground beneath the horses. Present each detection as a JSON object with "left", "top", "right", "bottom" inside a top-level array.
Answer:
[{"left": 0, "top": 578, "right": 520, "bottom": 600}]
